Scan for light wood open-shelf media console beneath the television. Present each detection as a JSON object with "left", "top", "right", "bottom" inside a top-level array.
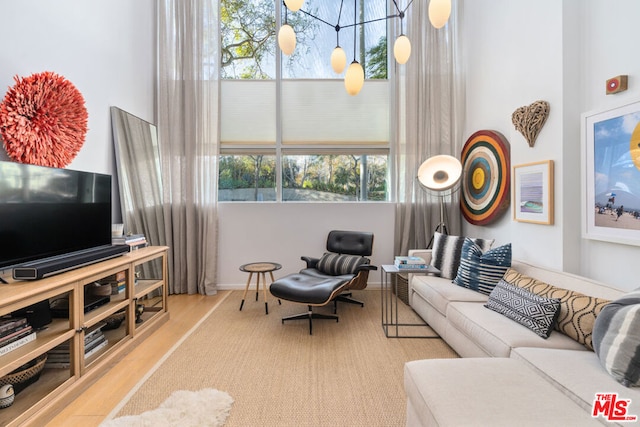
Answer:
[{"left": 0, "top": 246, "right": 169, "bottom": 426}]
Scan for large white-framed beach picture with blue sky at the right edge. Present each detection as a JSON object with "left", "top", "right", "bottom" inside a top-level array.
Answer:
[{"left": 582, "top": 101, "right": 640, "bottom": 245}]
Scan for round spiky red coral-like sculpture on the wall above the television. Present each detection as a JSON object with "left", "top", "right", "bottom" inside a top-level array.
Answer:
[{"left": 0, "top": 71, "right": 88, "bottom": 168}]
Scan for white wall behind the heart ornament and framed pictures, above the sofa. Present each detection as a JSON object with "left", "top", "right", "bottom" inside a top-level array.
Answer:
[{"left": 462, "top": 0, "right": 640, "bottom": 289}]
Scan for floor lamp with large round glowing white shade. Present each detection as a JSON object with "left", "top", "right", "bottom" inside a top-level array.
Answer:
[{"left": 417, "top": 154, "right": 462, "bottom": 248}]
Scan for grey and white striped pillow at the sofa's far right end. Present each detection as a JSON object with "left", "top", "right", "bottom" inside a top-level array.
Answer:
[{"left": 593, "top": 290, "right": 640, "bottom": 387}]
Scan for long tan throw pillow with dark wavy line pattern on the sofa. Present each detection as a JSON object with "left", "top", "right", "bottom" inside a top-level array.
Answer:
[{"left": 504, "top": 268, "right": 610, "bottom": 350}]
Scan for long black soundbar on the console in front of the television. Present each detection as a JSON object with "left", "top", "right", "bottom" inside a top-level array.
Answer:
[{"left": 13, "top": 245, "right": 129, "bottom": 280}]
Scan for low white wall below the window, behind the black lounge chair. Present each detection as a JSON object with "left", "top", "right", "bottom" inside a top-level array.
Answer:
[{"left": 218, "top": 202, "right": 395, "bottom": 288}]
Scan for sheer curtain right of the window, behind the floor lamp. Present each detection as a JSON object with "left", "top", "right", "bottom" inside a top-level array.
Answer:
[{"left": 394, "top": 0, "right": 464, "bottom": 255}]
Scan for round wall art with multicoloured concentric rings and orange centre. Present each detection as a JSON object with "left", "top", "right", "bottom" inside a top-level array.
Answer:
[{"left": 460, "top": 130, "right": 511, "bottom": 225}]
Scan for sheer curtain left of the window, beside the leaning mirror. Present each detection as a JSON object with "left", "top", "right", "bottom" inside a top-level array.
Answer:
[{"left": 158, "top": 0, "right": 220, "bottom": 295}]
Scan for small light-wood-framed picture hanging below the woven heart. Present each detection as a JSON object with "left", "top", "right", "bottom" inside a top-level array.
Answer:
[{"left": 512, "top": 160, "right": 553, "bottom": 225}]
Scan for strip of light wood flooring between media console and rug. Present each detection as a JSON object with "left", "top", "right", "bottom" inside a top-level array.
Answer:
[{"left": 47, "top": 291, "right": 230, "bottom": 427}]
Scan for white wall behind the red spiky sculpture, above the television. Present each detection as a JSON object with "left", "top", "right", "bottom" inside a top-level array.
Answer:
[{"left": 0, "top": 0, "right": 156, "bottom": 222}]
